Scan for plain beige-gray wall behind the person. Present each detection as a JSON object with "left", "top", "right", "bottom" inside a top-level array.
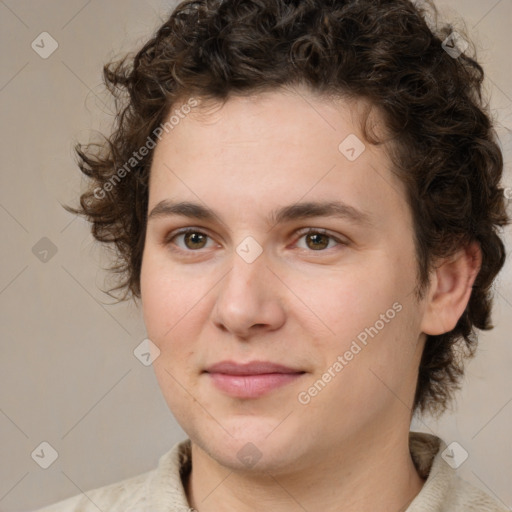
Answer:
[{"left": 0, "top": 0, "right": 512, "bottom": 512}]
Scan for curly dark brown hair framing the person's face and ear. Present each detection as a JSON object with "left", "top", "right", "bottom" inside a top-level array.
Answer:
[{"left": 66, "top": 0, "right": 509, "bottom": 415}]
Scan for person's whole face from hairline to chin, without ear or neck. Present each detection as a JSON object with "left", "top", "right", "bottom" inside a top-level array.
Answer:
[{"left": 141, "top": 90, "right": 424, "bottom": 472}]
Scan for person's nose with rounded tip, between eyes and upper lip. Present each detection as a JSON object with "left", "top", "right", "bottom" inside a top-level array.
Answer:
[{"left": 212, "top": 245, "right": 286, "bottom": 340}]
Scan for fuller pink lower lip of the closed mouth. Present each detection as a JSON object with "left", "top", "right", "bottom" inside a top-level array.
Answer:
[{"left": 208, "top": 373, "right": 304, "bottom": 398}]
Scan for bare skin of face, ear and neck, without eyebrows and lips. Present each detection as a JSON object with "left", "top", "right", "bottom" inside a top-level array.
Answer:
[{"left": 141, "top": 89, "right": 480, "bottom": 512}]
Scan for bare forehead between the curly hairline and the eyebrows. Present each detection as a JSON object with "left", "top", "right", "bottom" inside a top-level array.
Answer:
[{"left": 149, "top": 89, "right": 403, "bottom": 226}]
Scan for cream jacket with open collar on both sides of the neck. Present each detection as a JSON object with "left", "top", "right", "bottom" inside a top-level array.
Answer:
[{"left": 34, "top": 432, "right": 508, "bottom": 512}]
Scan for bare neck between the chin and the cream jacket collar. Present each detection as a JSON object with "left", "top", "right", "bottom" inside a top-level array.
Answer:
[{"left": 185, "top": 429, "right": 424, "bottom": 512}]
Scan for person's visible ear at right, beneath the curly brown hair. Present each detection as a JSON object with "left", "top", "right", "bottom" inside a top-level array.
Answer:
[{"left": 421, "top": 242, "right": 482, "bottom": 335}]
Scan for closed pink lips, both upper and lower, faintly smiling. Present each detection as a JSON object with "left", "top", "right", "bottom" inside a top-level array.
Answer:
[{"left": 205, "top": 361, "right": 305, "bottom": 398}]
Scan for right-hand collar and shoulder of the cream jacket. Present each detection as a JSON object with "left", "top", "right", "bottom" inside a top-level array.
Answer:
[{"left": 406, "top": 432, "right": 508, "bottom": 512}]
